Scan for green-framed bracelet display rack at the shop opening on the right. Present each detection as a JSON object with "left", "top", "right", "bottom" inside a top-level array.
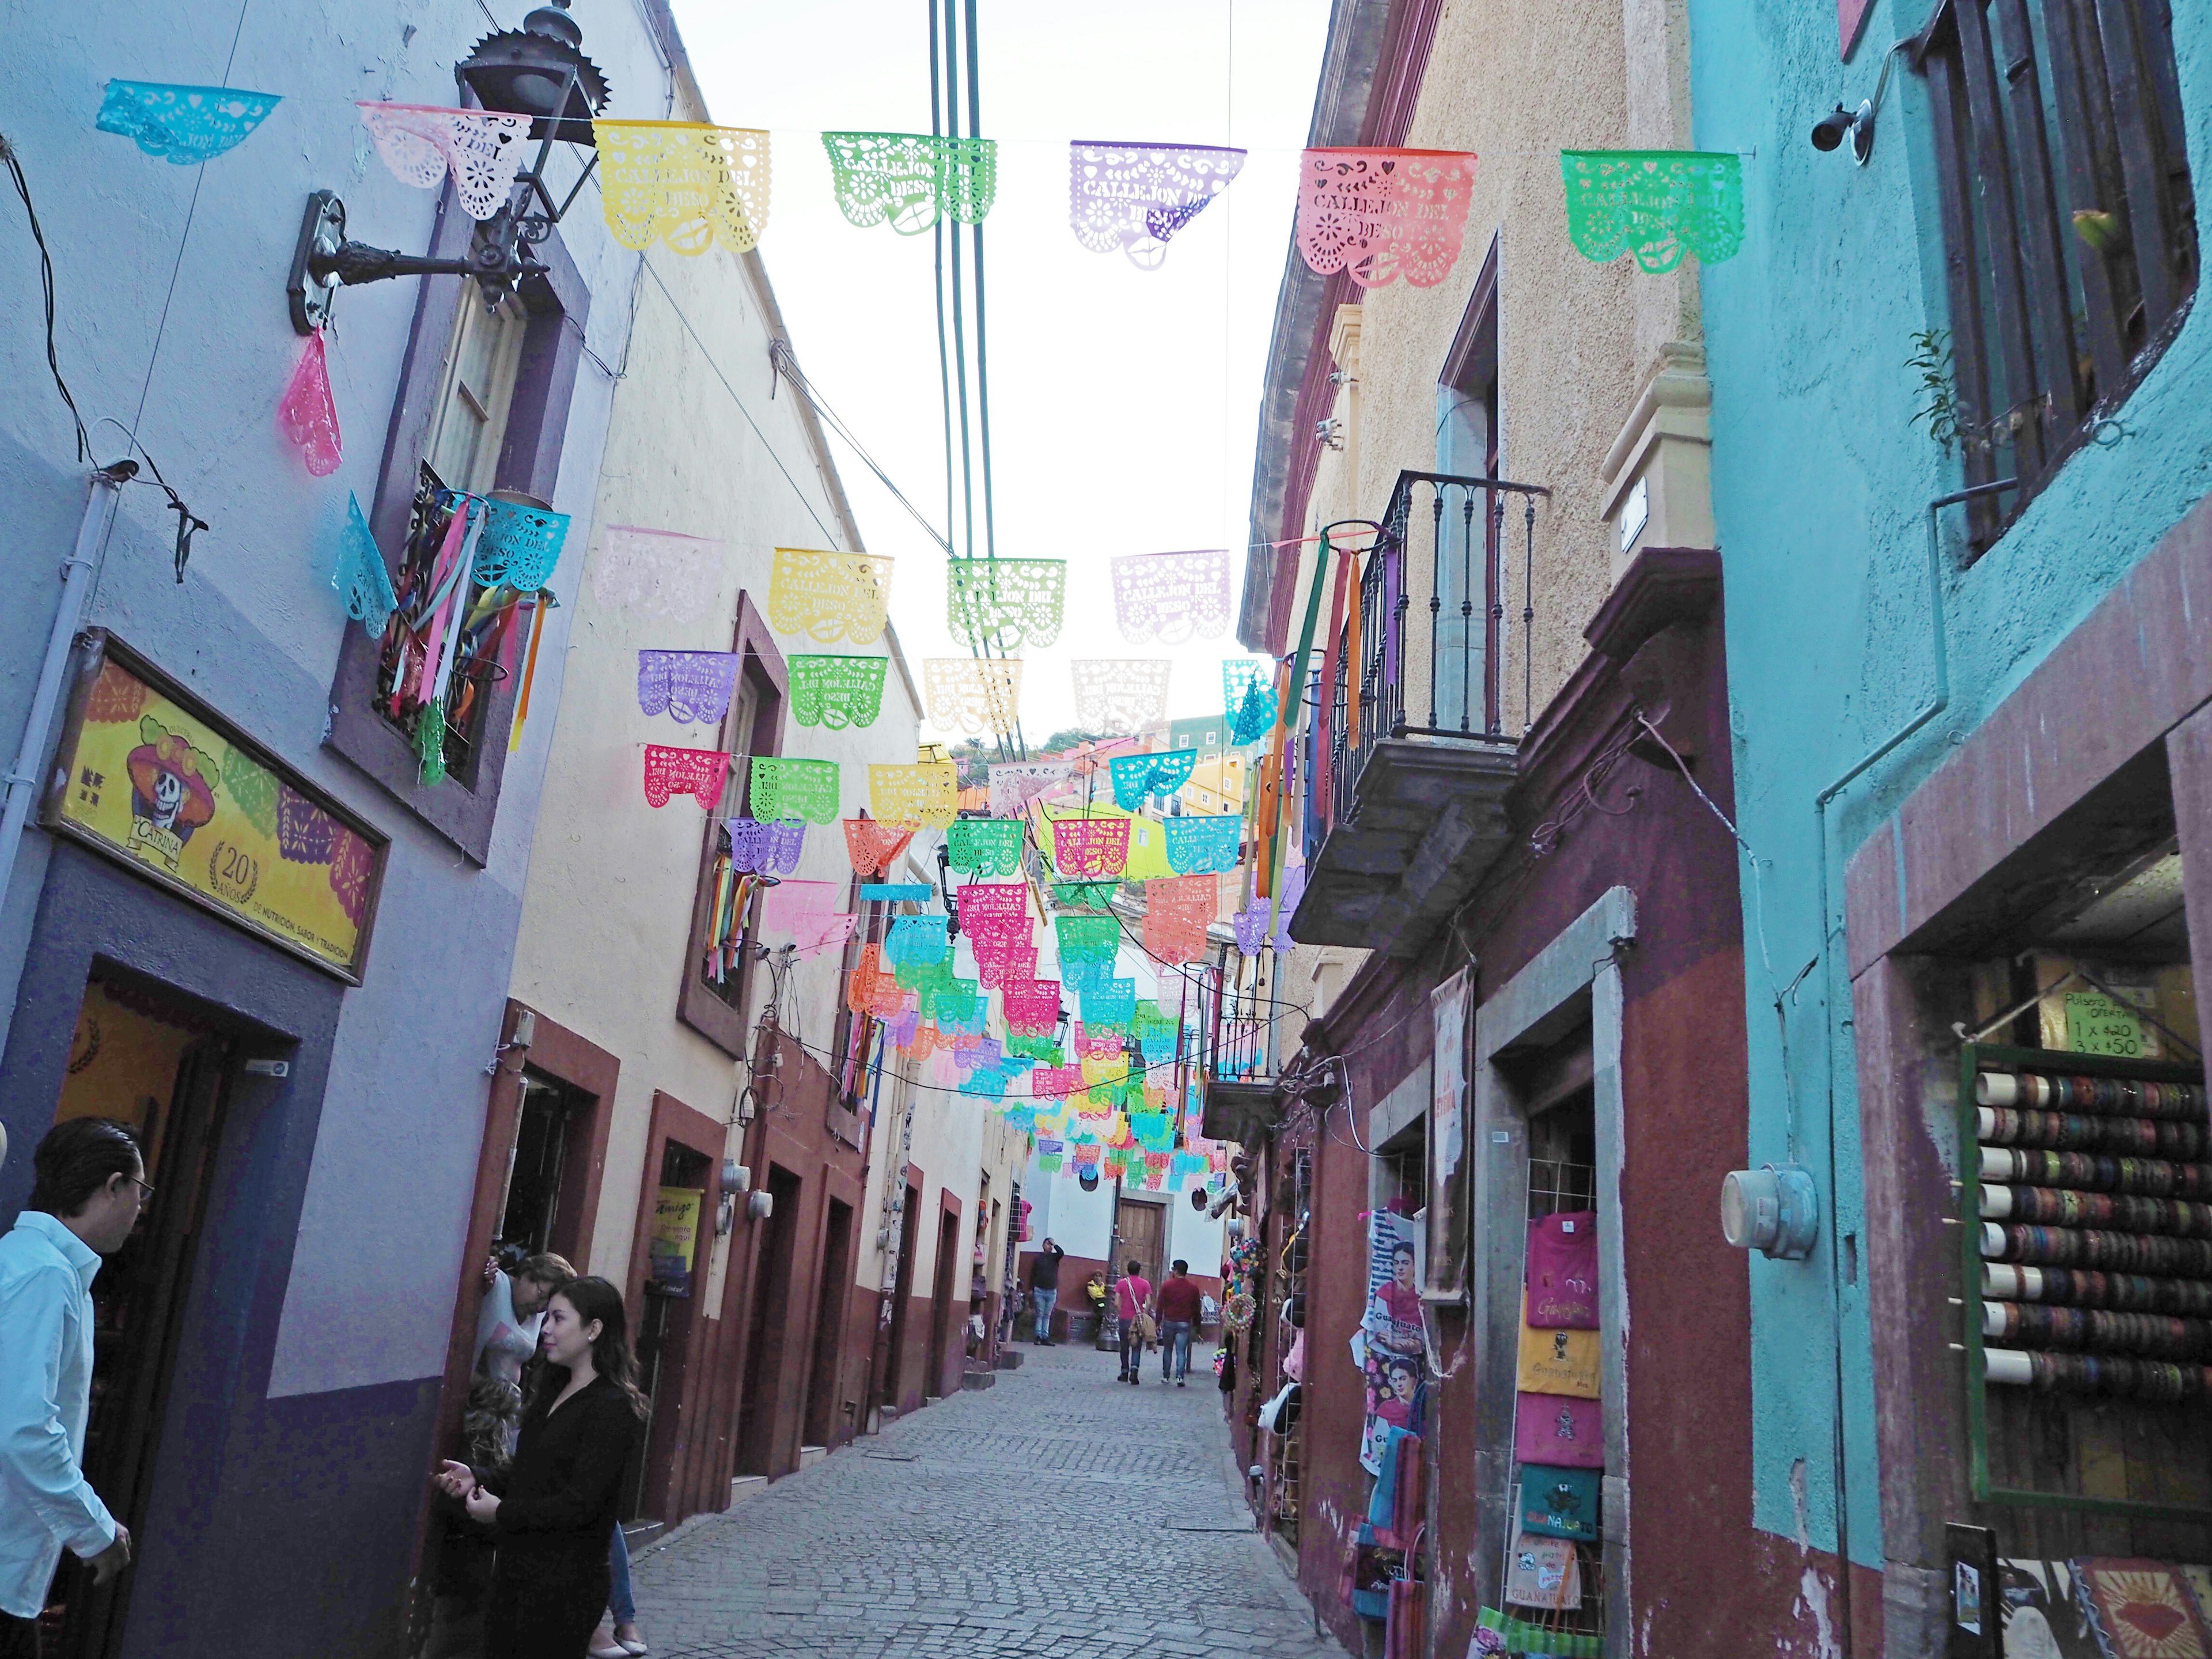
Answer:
[{"left": 1956, "top": 1044, "right": 2212, "bottom": 1522}]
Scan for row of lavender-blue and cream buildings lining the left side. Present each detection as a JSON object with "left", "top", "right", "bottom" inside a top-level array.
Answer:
[{"left": 0, "top": 0, "right": 1027, "bottom": 1659}]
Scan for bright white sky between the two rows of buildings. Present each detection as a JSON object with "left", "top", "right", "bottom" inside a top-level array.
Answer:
[{"left": 675, "top": 0, "right": 1330, "bottom": 741}]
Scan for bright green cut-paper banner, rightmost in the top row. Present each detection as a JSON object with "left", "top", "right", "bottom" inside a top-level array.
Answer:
[{"left": 1559, "top": 150, "right": 1743, "bottom": 276}]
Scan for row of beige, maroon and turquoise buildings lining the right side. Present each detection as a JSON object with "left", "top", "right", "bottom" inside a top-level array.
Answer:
[{"left": 1206, "top": 0, "right": 2212, "bottom": 1659}]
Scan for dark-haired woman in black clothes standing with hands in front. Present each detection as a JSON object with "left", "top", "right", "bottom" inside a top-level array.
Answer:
[{"left": 438, "top": 1279, "right": 646, "bottom": 1659}]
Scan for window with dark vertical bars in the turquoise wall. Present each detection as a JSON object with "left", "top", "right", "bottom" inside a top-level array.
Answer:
[{"left": 1914, "top": 0, "right": 2196, "bottom": 553}]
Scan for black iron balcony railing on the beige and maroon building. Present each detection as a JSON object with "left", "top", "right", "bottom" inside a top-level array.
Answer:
[{"left": 1320, "top": 471, "right": 1551, "bottom": 821}]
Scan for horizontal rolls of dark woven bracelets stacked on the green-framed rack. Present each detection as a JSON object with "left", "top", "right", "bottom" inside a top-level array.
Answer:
[{"left": 1973, "top": 1073, "right": 2212, "bottom": 1400}]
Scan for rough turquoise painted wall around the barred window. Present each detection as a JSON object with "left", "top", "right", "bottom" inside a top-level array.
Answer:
[{"left": 1690, "top": 0, "right": 2212, "bottom": 1566}]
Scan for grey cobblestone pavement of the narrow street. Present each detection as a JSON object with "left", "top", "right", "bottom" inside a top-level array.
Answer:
[{"left": 637, "top": 1345, "right": 1345, "bottom": 1659}]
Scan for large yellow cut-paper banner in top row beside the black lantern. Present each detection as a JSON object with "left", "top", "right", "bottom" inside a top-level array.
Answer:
[{"left": 590, "top": 118, "right": 767, "bottom": 255}]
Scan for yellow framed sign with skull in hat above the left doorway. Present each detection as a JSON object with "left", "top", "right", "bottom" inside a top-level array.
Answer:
[{"left": 42, "top": 628, "right": 385, "bottom": 984}]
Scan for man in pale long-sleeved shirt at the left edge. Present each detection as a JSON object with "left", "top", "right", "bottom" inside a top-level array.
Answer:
[{"left": 0, "top": 1117, "right": 153, "bottom": 1659}]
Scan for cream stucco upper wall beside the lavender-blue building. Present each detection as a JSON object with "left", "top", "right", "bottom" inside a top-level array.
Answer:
[{"left": 511, "top": 68, "right": 927, "bottom": 1319}]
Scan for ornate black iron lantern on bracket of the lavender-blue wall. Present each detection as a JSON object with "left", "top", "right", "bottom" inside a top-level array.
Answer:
[{"left": 285, "top": 0, "right": 608, "bottom": 334}]
